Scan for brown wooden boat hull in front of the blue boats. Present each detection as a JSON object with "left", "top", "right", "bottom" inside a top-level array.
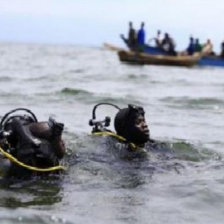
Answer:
[{"left": 118, "top": 50, "right": 200, "bottom": 67}]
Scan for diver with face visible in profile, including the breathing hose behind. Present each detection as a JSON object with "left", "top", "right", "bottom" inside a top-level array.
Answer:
[{"left": 89, "top": 103, "right": 155, "bottom": 158}]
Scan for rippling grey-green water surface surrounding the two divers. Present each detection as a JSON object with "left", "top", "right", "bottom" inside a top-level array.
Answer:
[{"left": 0, "top": 43, "right": 224, "bottom": 224}]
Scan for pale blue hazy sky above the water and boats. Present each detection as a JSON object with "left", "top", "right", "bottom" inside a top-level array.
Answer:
[{"left": 0, "top": 0, "right": 224, "bottom": 51}]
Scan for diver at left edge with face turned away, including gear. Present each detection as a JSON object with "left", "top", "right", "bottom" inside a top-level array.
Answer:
[{"left": 0, "top": 108, "right": 65, "bottom": 178}]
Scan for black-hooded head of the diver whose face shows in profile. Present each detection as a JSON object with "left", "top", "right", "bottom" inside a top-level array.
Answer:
[{"left": 114, "top": 105, "right": 149, "bottom": 145}]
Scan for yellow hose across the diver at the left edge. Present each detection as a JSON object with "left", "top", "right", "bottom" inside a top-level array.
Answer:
[{"left": 0, "top": 147, "right": 66, "bottom": 172}]
